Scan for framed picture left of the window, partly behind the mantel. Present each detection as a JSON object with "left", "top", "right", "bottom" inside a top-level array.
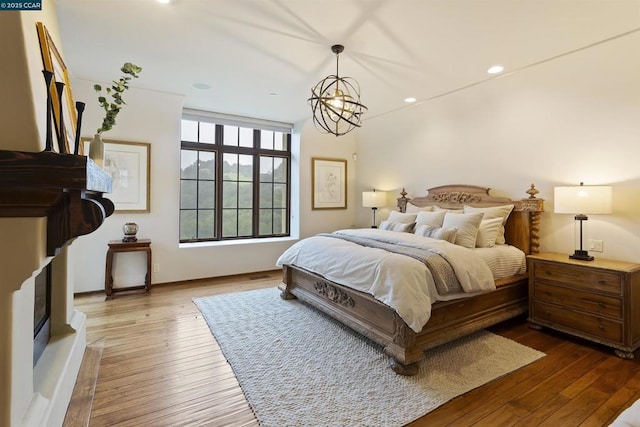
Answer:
[{"left": 83, "top": 139, "right": 151, "bottom": 212}]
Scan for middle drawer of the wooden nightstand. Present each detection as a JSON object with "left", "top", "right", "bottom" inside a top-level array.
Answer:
[{"left": 532, "top": 282, "right": 622, "bottom": 319}]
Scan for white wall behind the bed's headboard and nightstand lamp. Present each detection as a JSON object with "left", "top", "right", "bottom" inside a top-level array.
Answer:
[{"left": 357, "top": 33, "right": 640, "bottom": 261}]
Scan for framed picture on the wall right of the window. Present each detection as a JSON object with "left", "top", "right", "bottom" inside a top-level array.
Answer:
[{"left": 311, "top": 157, "right": 347, "bottom": 209}]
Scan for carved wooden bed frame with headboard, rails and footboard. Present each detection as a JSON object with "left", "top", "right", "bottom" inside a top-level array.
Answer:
[{"left": 280, "top": 184, "right": 544, "bottom": 375}]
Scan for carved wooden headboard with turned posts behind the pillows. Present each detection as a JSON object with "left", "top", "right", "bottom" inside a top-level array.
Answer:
[{"left": 398, "top": 184, "right": 544, "bottom": 254}]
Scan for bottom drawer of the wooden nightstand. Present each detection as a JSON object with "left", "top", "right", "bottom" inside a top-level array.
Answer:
[{"left": 531, "top": 301, "right": 622, "bottom": 342}]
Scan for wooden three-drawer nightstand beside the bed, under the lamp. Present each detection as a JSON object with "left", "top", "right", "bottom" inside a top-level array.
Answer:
[{"left": 527, "top": 253, "right": 640, "bottom": 359}]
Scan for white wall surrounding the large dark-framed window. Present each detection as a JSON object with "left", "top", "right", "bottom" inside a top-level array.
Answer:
[{"left": 71, "top": 80, "right": 356, "bottom": 292}]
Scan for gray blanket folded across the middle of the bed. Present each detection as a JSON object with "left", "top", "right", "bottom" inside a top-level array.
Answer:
[{"left": 320, "top": 233, "right": 463, "bottom": 295}]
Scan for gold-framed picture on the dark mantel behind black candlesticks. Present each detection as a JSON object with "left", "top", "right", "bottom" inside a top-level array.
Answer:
[{"left": 36, "top": 22, "right": 77, "bottom": 154}]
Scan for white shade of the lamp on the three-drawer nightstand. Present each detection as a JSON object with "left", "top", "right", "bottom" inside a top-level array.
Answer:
[{"left": 553, "top": 185, "right": 612, "bottom": 214}]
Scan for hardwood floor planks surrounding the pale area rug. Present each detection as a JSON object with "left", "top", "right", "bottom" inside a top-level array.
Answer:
[{"left": 64, "top": 271, "right": 640, "bottom": 427}]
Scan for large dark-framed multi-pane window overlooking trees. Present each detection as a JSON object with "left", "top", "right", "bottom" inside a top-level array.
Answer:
[{"left": 180, "top": 112, "right": 291, "bottom": 243}]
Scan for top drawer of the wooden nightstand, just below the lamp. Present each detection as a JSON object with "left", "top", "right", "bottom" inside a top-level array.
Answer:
[{"left": 533, "top": 262, "right": 622, "bottom": 295}]
